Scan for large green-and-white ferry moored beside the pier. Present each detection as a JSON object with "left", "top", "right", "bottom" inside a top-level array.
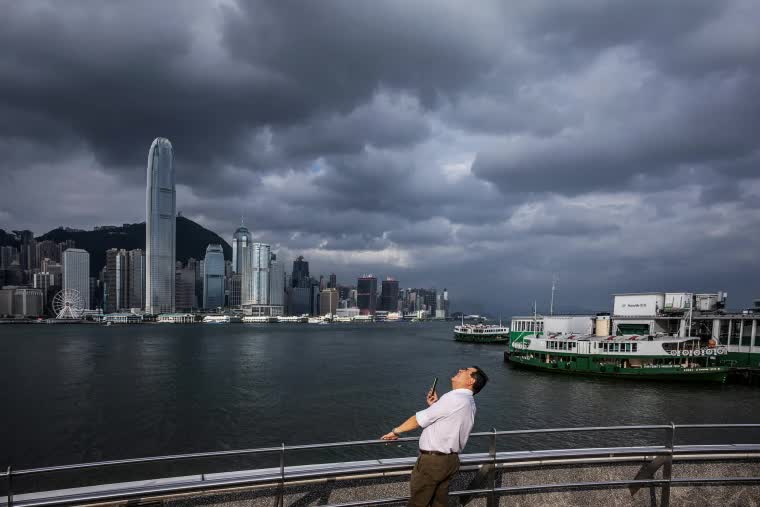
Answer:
[{"left": 506, "top": 334, "right": 729, "bottom": 383}]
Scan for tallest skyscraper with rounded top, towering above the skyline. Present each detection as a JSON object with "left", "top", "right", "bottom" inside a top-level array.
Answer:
[{"left": 145, "top": 137, "right": 177, "bottom": 313}]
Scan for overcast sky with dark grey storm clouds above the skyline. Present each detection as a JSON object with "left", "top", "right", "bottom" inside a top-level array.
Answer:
[{"left": 0, "top": 0, "right": 760, "bottom": 315}]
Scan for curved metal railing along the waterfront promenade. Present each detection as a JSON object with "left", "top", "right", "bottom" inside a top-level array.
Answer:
[{"left": 0, "top": 423, "right": 760, "bottom": 507}]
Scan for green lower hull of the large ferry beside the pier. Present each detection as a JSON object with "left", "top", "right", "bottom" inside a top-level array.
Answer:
[{"left": 504, "top": 354, "right": 728, "bottom": 384}]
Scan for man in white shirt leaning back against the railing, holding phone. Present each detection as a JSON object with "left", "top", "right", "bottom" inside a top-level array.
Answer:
[{"left": 381, "top": 366, "right": 488, "bottom": 507}]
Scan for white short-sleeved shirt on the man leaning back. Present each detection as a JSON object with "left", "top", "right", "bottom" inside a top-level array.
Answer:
[{"left": 415, "top": 389, "right": 475, "bottom": 454}]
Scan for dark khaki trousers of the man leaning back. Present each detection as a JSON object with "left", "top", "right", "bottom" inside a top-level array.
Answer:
[{"left": 408, "top": 454, "right": 459, "bottom": 507}]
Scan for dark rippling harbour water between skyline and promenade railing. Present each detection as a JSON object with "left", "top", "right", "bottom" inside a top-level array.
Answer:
[{"left": 0, "top": 322, "right": 760, "bottom": 474}]
